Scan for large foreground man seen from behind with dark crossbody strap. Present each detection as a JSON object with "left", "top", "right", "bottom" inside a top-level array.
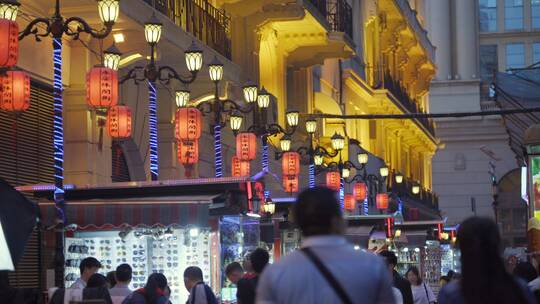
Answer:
[{"left": 256, "top": 187, "right": 394, "bottom": 304}]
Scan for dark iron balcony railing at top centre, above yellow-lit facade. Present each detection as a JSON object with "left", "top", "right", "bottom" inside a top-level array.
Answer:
[{"left": 309, "top": 0, "right": 353, "bottom": 38}]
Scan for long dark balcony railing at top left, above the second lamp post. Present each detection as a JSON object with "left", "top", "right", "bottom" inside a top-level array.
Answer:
[{"left": 144, "top": 0, "right": 231, "bottom": 59}]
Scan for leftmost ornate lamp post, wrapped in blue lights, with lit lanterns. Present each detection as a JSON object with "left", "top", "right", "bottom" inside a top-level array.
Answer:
[{"left": 0, "top": 0, "right": 120, "bottom": 286}]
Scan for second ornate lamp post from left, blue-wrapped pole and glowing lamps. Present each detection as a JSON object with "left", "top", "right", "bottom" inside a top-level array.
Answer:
[{"left": 119, "top": 14, "right": 204, "bottom": 181}]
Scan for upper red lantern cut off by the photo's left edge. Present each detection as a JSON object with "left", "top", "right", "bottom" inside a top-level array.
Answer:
[{"left": 0, "top": 19, "right": 19, "bottom": 68}]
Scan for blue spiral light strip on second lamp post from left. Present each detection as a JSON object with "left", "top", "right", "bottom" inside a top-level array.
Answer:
[{"left": 148, "top": 81, "right": 159, "bottom": 181}]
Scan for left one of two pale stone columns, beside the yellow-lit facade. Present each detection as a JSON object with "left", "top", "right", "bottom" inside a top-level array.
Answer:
[{"left": 426, "top": 0, "right": 452, "bottom": 80}]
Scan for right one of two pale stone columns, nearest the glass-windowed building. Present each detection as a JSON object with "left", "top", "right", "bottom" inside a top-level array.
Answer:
[{"left": 455, "top": 0, "right": 478, "bottom": 80}]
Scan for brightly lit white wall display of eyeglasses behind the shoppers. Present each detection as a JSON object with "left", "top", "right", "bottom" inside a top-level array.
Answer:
[{"left": 65, "top": 227, "right": 212, "bottom": 303}]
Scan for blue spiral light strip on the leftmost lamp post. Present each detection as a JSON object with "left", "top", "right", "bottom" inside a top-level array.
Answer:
[{"left": 53, "top": 38, "right": 66, "bottom": 223}]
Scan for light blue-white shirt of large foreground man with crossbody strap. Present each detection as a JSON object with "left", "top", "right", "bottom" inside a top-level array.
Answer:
[{"left": 256, "top": 236, "right": 394, "bottom": 304}]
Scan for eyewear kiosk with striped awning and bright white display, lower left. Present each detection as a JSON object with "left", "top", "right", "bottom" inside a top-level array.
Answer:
[{"left": 21, "top": 178, "right": 260, "bottom": 303}]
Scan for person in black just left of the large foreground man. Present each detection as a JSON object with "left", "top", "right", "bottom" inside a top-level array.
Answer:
[{"left": 236, "top": 248, "right": 270, "bottom": 304}]
